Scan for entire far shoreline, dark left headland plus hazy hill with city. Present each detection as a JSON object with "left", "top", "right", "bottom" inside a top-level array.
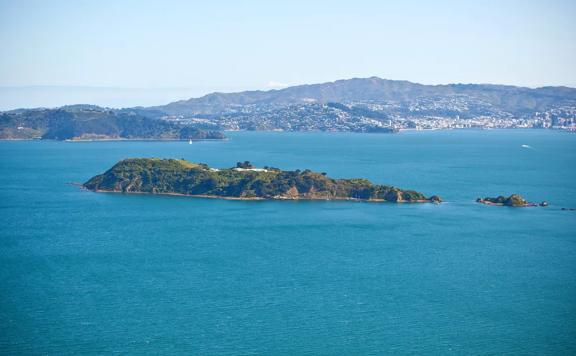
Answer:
[{"left": 0, "top": 77, "right": 576, "bottom": 139}]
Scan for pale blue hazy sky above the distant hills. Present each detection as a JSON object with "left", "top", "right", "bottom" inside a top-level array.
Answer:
[{"left": 0, "top": 0, "right": 576, "bottom": 108}]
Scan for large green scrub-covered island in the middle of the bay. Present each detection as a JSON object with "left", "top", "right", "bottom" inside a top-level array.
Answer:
[{"left": 82, "top": 158, "right": 442, "bottom": 203}]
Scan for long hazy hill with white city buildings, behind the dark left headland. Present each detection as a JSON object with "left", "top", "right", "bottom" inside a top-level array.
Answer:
[{"left": 153, "top": 77, "right": 576, "bottom": 132}]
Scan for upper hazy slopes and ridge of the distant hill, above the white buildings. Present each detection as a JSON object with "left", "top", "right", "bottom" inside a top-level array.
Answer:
[{"left": 153, "top": 77, "right": 576, "bottom": 115}]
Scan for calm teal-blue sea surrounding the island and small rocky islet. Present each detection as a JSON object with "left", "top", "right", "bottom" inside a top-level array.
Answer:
[{"left": 0, "top": 130, "right": 576, "bottom": 355}]
